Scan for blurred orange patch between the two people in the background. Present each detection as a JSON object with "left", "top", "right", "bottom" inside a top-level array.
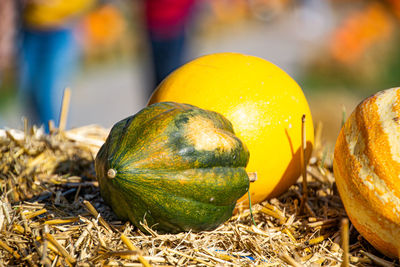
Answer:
[{"left": 78, "top": 0, "right": 143, "bottom": 67}]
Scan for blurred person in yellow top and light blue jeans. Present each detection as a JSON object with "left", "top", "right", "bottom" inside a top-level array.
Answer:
[{"left": 19, "top": 0, "right": 95, "bottom": 132}]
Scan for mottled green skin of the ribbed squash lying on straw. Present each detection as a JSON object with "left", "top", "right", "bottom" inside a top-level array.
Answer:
[{"left": 95, "top": 102, "right": 249, "bottom": 233}]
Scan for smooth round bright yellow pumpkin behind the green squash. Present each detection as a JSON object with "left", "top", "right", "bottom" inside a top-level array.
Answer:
[{"left": 149, "top": 53, "right": 314, "bottom": 205}]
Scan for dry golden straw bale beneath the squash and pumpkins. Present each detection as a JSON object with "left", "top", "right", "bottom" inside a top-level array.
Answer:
[{"left": 0, "top": 126, "right": 398, "bottom": 266}]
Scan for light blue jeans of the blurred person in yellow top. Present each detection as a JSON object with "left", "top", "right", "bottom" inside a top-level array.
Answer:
[{"left": 19, "top": 28, "right": 79, "bottom": 131}]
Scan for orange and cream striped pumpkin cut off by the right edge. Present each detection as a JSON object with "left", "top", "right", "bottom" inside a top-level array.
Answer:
[{"left": 333, "top": 88, "right": 400, "bottom": 257}]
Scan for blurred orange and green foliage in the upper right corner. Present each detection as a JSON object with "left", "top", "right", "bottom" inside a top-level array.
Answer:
[{"left": 301, "top": 1, "right": 400, "bottom": 94}]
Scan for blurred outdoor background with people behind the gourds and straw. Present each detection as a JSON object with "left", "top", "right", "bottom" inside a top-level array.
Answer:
[{"left": 0, "top": 0, "right": 400, "bottom": 151}]
